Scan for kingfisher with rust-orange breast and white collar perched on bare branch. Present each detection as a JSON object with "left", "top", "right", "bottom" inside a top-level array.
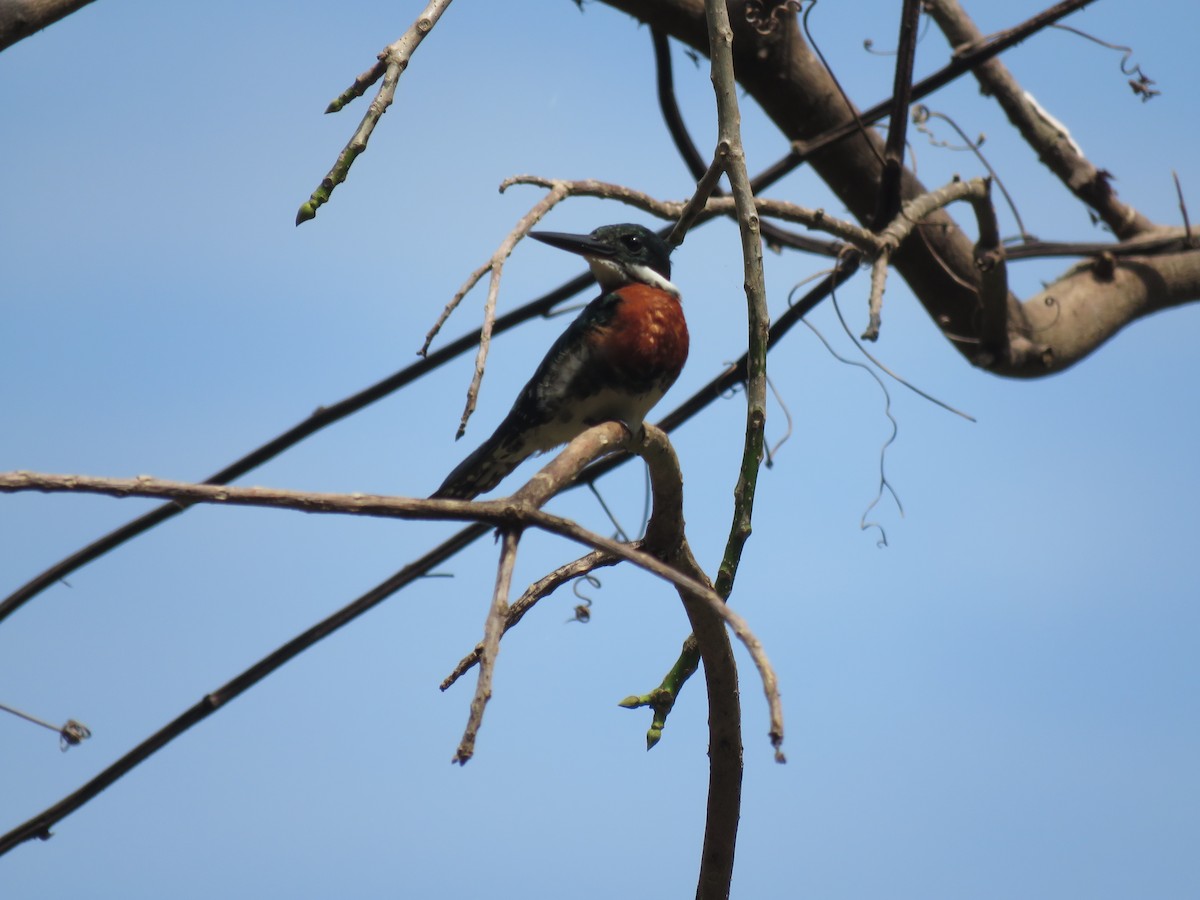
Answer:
[{"left": 433, "top": 224, "right": 688, "bottom": 500}]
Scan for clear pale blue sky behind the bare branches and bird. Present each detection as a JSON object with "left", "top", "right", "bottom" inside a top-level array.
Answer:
[{"left": 0, "top": 0, "right": 1200, "bottom": 900}]
